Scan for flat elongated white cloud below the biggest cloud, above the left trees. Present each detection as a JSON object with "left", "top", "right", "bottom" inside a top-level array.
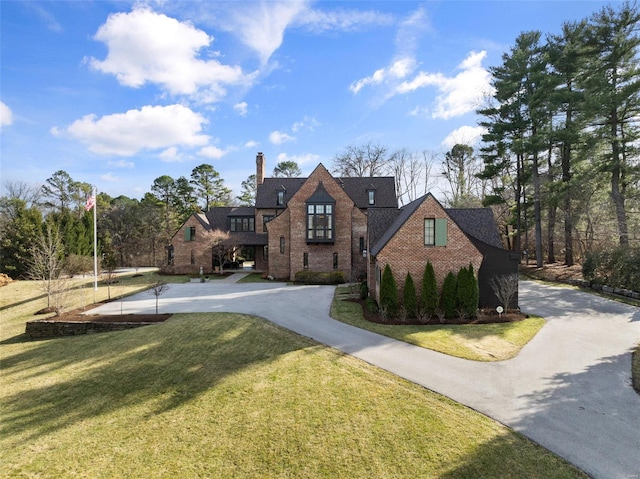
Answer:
[{"left": 58, "top": 105, "right": 209, "bottom": 156}]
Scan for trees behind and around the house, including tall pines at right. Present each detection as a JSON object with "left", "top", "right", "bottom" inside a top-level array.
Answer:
[{"left": 0, "top": 3, "right": 640, "bottom": 278}]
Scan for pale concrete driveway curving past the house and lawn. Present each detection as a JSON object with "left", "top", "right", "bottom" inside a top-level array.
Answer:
[{"left": 93, "top": 281, "right": 640, "bottom": 479}]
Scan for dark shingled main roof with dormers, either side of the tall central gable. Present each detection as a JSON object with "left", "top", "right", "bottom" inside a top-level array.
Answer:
[{"left": 256, "top": 176, "right": 398, "bottom": 209}]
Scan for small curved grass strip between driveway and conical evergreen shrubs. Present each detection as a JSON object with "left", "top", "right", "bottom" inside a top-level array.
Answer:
[{"left": 331, "top": 286, "right": 544, "bottom": 361}]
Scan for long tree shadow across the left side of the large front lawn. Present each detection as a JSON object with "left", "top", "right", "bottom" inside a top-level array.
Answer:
[{"left": 0, "top": 314, "right": 312, "bottom": 446}]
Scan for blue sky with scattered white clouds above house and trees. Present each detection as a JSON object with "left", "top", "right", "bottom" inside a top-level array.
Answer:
[{"left": 0, "top": 0, "right": 616, "bottom": 198}]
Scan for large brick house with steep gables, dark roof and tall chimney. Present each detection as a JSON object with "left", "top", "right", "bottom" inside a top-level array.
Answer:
[{"left": 168, "top": 153, "right": 518, "bottom": 307}]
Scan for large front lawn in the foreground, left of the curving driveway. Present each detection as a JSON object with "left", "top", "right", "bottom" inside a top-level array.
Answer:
[{"left": 0, "top": 283, "right": 586, "bottom": 479}]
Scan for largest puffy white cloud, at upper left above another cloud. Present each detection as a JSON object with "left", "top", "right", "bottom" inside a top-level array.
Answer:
[{"left": 89, "top": 8, "right": 252, "bottom": 103}]
